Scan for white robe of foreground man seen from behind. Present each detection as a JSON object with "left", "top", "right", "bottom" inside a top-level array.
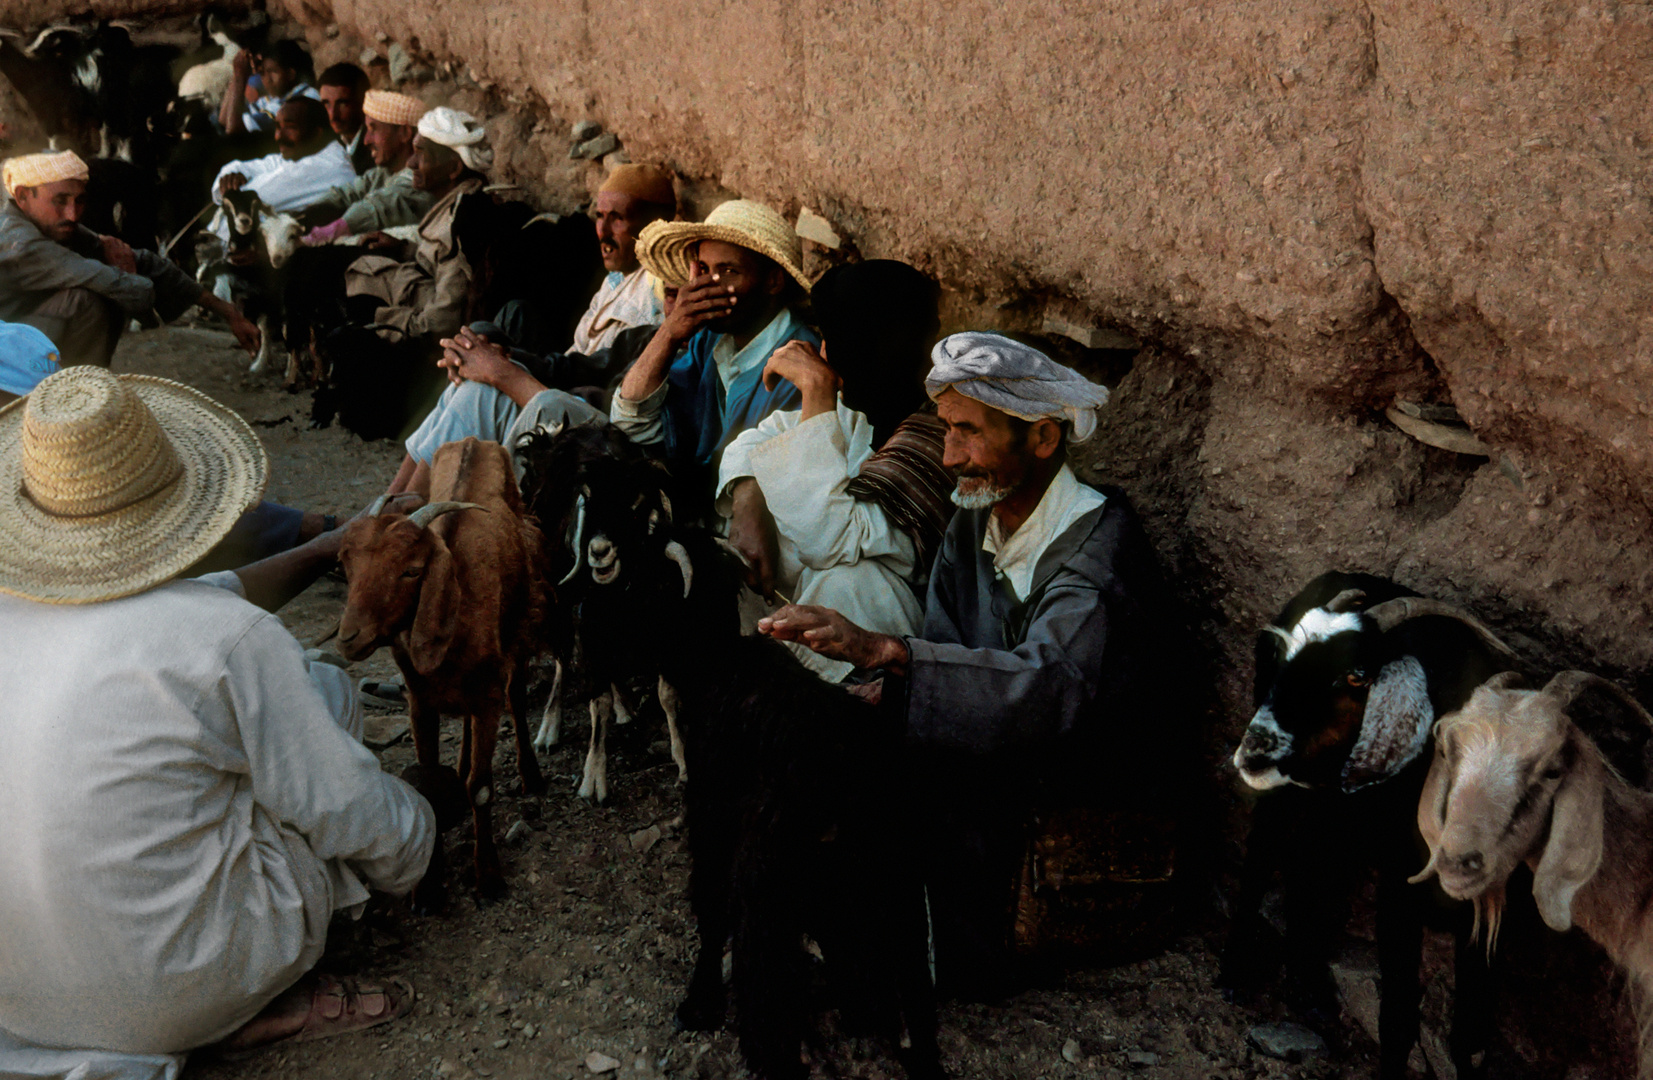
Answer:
[{"left": 0, "top": 581, "right": 436, "bottom": 1058}]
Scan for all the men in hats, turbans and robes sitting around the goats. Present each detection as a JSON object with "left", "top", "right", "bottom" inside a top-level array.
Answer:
[{"left": 0, "top": 33, "right": 1176, "bottom": 1077}]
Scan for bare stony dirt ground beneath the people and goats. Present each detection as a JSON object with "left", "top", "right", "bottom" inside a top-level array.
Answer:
[{"left": 106, "top": 326, "right": 1613, "bottom": 1080}]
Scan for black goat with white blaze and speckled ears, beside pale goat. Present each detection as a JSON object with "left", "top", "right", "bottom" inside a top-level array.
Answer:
[{"left": 1222, "top": 572, "right": 1519, "bottom": 1080}]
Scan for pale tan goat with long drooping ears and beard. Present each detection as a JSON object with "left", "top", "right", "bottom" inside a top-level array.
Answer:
[{"left": 1413, "top": 671, "right": 1653, "bottom": 1078}]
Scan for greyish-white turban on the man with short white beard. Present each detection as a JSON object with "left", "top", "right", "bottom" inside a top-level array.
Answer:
[{"left": 924, "top": 331, "right": 1108, "bottom": 443}]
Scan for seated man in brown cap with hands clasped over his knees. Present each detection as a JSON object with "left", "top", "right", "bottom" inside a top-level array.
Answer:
[{"left": 381, "top": 165, "right": 678, "bottom": 491}]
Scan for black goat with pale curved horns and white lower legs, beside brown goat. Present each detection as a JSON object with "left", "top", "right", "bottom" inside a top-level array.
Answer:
[{"left": 514, "top": 425, "right": 688, "bottom": 804}]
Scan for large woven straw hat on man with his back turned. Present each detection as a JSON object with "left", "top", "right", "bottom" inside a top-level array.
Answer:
[{"left": 0, "top": 367, "right": 268, "bottom": 604}]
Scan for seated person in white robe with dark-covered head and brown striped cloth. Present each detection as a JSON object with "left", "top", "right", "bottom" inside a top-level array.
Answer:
[{"left": 717, "top": 260, "right": 952, "bottom": 681}]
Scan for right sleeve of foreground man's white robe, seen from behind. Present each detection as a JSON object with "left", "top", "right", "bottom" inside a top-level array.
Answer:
[{"left": 225, "top": 615, "right": 436, "bottom": 895}]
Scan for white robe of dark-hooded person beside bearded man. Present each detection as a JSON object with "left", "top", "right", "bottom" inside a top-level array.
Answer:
[{"left": 717, "top": 400, "right": 924, "bottom": 681}]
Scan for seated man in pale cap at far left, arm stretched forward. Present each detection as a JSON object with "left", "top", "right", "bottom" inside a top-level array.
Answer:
[{"left": 0, "top": 151, "right": 260, "bottom": 367}]
